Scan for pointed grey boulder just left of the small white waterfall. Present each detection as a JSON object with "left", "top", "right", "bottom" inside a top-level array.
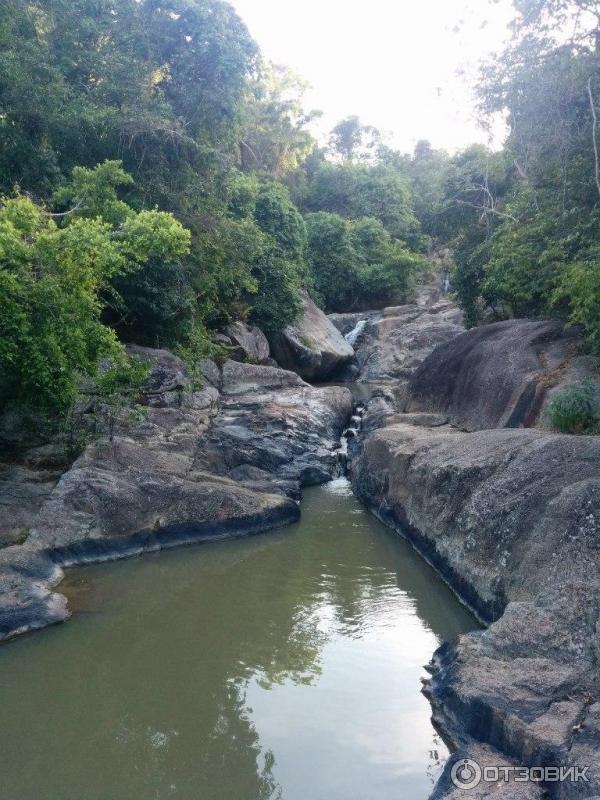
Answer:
[{"left": 270, "top": 291, "right": 354, "bottom": 382}]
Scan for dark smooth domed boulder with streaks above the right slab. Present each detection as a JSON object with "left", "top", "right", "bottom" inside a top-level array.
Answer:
[{"left": 406, "top": 320, "right": 582, "bottom": 430}]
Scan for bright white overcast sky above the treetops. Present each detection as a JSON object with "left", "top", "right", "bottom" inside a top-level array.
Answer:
[{"left": 231, "top": 0, "right": 513, "bottom": 152}]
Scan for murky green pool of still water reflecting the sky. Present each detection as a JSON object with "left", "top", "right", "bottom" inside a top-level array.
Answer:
[{"left": 0, "top": 480, "right": 475, "bottom": 800}]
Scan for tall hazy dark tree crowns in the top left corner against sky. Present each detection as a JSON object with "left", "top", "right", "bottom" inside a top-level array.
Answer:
[{"left": 0, "top": 0, "right": 257, "bottom": 205}]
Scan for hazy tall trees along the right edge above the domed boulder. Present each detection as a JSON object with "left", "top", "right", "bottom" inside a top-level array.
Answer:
[{"left": 436, "top": 0, "right": 600, "bottom": 348}]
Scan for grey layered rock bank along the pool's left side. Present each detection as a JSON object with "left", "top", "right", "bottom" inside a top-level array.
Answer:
[{"left": 0, "top": 300, "right": 353, "bottom": 639}]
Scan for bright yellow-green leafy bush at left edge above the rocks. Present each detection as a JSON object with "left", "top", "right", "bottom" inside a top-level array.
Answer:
[{"left": 0, "top": 165, "right": 189, "bottom": 410}]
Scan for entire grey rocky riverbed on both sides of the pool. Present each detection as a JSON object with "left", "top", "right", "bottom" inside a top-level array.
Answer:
[{"left": 0, "top": 287, "right": 600, "bottom": 800}]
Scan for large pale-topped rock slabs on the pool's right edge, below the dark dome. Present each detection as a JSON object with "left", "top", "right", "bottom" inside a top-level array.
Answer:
[{"left": 352, "top": 424, "right": 600, "bottom": 798}]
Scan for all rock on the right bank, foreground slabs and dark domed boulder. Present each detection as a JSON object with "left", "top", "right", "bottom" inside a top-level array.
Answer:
[{"left": 344, "top": 296, "right": 600, "bottom": 799}]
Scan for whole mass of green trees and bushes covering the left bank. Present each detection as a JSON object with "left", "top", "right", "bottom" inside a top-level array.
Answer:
[{"left": 0, "top": 0, "right": 432, "bottom": 432}]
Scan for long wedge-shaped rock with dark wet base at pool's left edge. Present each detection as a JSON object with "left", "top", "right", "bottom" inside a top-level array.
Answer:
[{"left": 30, "top": 460, "right": 299, "bottom": 565}]
